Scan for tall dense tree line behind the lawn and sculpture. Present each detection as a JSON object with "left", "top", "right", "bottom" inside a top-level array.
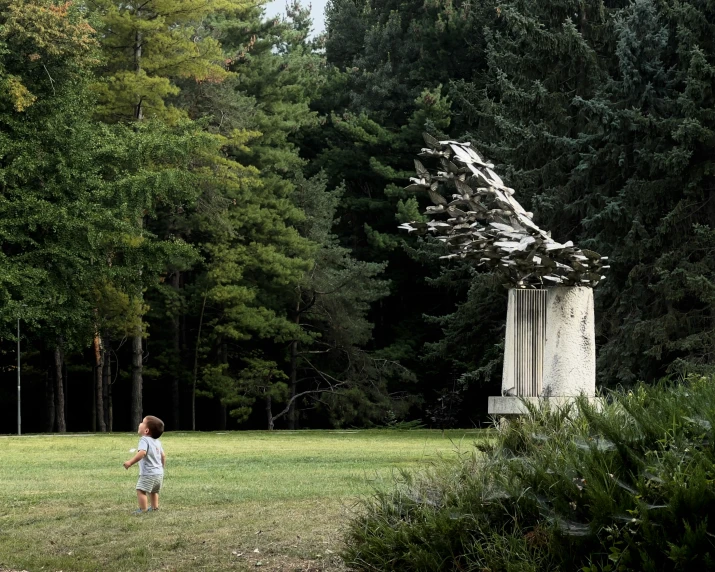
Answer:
[{"left": 0, "top": 0, "right": 715, "bottom": 432}]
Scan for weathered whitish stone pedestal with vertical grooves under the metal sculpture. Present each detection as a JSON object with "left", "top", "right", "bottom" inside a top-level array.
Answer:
[{"left": 488, "top": 288, "right": 596, "bottom": 415}]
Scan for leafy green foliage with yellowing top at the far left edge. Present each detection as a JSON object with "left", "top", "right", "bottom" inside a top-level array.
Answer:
[{"left": 0, "top": 2, "right": 126, "bottom": 348}]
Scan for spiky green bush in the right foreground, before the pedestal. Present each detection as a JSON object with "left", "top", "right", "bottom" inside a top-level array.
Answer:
[{"left": 343, "top": 378, "right": 715, "bottom": 572}]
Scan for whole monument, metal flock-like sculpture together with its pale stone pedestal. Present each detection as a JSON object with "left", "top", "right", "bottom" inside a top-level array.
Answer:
[{"left": 400, "top": 133, "right": 608, "bottom": 415}]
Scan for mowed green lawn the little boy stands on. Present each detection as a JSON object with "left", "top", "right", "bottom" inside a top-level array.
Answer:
[{"left": 0, "top": 430, "right": 487, "bottom": 572}]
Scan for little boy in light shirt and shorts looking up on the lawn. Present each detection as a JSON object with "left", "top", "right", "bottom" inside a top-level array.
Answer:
[{"left": 124, "top": 415, "right": 166, "bottom": 514}]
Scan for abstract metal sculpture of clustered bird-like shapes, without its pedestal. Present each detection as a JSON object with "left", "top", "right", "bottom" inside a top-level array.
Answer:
[{"left": 399, "top": 133, "right": 608, "bottom": 289}]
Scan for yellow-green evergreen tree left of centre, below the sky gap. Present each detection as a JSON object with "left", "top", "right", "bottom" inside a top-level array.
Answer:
[{"left": 168, "top": 4, "right": 320, "bottom": 424}]
